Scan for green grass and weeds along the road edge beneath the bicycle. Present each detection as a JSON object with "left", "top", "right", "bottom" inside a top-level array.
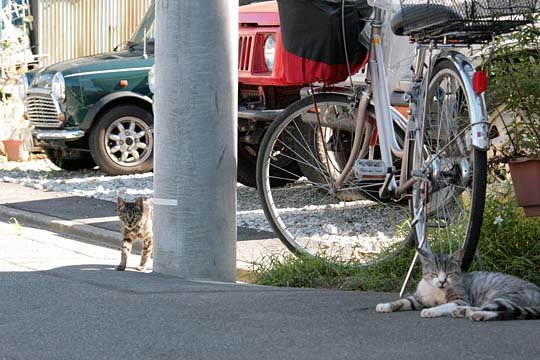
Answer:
[{"left": 253, "top": 184, "right": 540, "bottom": 292}]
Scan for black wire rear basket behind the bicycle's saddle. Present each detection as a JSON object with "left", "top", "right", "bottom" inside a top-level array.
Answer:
[{"left": 400, "top": 0, "right": 537, "bottom": 43}]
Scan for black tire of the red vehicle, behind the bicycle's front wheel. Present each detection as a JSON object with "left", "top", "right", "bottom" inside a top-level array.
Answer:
[{"left": 237, "top": 142, "right": 301, "bottom": 187}]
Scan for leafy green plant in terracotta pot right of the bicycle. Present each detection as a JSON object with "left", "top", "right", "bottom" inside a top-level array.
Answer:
[{"left": 490, "top": 17, "right": 540, "bottom": 216}]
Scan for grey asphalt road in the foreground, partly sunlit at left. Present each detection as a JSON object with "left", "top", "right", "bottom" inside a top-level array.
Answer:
[{"left": 0, "top": 221, "right": 540, "bottom": 360}]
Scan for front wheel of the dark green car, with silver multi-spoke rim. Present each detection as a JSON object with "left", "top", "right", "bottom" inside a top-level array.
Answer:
[{"left": 89, "top": 105, "right": 154, "bottom": 175}]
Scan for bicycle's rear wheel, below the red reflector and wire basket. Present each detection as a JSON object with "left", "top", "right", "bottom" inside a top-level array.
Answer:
[{"left": 412, "top": 60, "right": 487, "bottom": 271}]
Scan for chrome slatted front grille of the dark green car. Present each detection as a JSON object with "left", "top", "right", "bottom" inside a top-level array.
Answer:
[{"left": 25, "top": 93, "right": 61, "bottom": 128}]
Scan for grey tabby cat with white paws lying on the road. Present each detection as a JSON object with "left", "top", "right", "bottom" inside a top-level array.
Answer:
[{"left": 376, "top": 250, "right": 540, "bottom": 321}]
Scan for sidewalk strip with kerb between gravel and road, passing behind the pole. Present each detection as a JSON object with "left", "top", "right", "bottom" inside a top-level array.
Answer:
[{"left": 0, "top": 182, "right": 288, "bottom": 269}]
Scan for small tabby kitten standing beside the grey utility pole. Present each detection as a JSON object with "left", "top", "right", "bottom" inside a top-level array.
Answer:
[{"left": 116, "top": 197, "right": 154, "bottom": 271}]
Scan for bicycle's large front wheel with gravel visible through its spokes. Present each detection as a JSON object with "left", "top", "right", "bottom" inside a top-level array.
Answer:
[{"left": 257, "top": 94, "right": 410, "bottom": 263}]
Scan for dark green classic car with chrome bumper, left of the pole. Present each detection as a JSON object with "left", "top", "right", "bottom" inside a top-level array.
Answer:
[{"left": 23, "top": 4, "right": 154, "bottom": 175}]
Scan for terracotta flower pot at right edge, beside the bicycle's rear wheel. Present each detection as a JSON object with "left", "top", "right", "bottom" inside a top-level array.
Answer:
[{"left": 508, "top": 158, "right": 540, "bottom": 216}]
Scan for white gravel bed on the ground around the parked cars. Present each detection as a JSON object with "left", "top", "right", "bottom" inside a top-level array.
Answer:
[{"left": 0, "top": 156, "right": 404, "bottom": 257}]
